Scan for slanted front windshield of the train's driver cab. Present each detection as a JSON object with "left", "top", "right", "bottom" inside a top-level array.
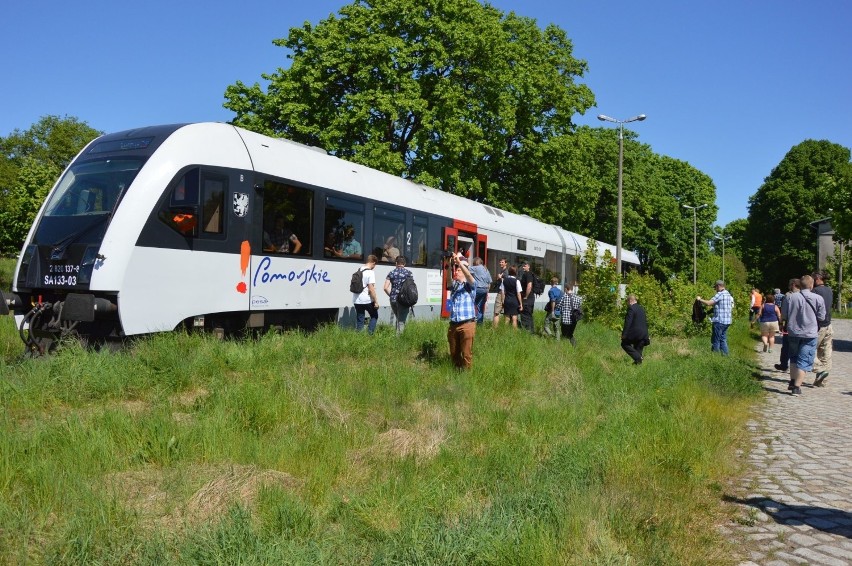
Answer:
[{"left": 44, "top": 159, "right": 142, "bottom": 217}]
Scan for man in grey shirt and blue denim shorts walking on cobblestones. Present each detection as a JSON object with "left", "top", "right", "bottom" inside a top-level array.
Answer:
[{"left": 781, "top": 275, "right": 825, "bottom": 395}]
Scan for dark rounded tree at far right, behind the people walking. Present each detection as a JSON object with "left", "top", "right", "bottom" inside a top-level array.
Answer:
[{"left": 743, "top": 140, "right": 850, "bottom": 289}]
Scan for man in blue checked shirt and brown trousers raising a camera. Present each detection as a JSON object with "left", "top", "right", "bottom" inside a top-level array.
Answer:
[{"left": 447, "top": 253, "right": 476, "bottom": 369}]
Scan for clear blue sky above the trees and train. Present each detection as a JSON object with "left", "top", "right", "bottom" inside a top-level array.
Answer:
[{"left": 0, "top": 0, "right": 852, "bottom": 230}]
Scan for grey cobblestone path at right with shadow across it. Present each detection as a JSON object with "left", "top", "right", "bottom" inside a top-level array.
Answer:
[{"left": 721, "top": 319, "right": 852, "bottom": 566}]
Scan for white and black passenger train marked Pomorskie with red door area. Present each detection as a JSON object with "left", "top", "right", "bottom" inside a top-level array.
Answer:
[{"left": 0, "top": 122, "right": 639, "bottom": 352}]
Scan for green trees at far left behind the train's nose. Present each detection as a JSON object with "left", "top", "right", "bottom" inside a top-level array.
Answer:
[{"left": 0, "top": 116, "right": 101, "bottom": 254}]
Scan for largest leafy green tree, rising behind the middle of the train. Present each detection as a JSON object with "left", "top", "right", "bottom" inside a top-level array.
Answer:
[{"left": 225, "top": 0, "right": 594, "bottom": 212}]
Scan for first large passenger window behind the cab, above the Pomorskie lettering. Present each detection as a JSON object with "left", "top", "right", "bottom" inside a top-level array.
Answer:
[{"left": 263, "top": 181, "right": 314, "bottom": 255}]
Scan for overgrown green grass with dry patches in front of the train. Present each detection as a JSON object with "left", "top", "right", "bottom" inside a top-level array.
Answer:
[{"left": 0, "top": 321, "right": 759, "bottom": 564}]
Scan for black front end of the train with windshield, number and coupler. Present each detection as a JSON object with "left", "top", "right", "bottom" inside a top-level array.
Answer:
[{"left": 0, "top": 128, "right": 176, "bottom": 354}]
